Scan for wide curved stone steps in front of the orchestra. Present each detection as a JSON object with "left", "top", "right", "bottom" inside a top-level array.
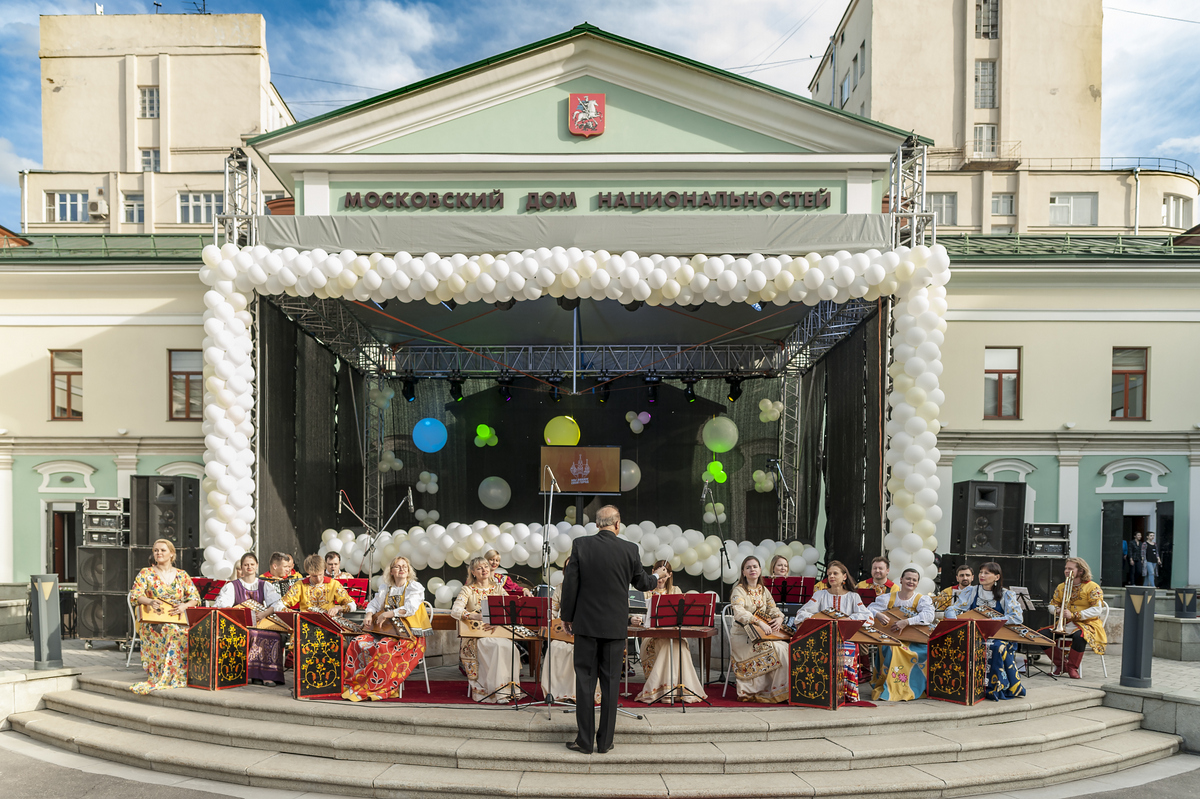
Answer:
[{"left": 8, "top": 672, "right": 1180, "bottom": 798}]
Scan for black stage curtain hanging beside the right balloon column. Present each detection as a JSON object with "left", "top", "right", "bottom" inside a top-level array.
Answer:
[{"left": 823, "top": 305, "right": 883, "bottom": 575}]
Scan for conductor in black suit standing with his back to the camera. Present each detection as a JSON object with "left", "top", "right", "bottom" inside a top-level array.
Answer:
[{"left": 562, "top": 505, "right": 659, "bottom": 755}]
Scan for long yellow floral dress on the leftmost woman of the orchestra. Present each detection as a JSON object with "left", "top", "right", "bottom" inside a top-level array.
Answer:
[{"left": 130, "top": 566, "right": 200, "bottom": 693}]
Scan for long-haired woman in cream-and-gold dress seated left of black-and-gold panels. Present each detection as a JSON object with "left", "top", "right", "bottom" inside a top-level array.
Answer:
[{"left": 730, "top": 555, "right": 787, "bottom": 703}]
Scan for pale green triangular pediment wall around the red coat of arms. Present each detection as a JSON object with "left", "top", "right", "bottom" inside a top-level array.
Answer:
[{"left": 360, "top": 77, "right": 805, "bottom": 154}]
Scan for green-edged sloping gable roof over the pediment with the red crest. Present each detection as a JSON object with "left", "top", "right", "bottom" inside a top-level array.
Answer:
[{"left": 248, "top": 23, "right": 934, "bottom": 146}]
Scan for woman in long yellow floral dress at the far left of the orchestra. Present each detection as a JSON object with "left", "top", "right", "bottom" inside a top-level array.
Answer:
[{"left": 130, "top": 539, "right": 200, "bottom": 695}]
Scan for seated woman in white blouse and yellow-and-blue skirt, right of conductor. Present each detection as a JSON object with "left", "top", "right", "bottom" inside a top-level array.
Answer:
[{"left": 866, "top": 569, "right": 934, "bottom": 702}]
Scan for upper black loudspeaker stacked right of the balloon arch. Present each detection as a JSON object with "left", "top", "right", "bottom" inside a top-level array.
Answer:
[{"left": 950, "top": 480, "right": 1025, "bottom": 555}]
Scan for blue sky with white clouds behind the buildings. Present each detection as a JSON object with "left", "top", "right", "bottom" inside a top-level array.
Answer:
[{"left": 0, "top": 0, "right": 1200, "bottom": 229}]
